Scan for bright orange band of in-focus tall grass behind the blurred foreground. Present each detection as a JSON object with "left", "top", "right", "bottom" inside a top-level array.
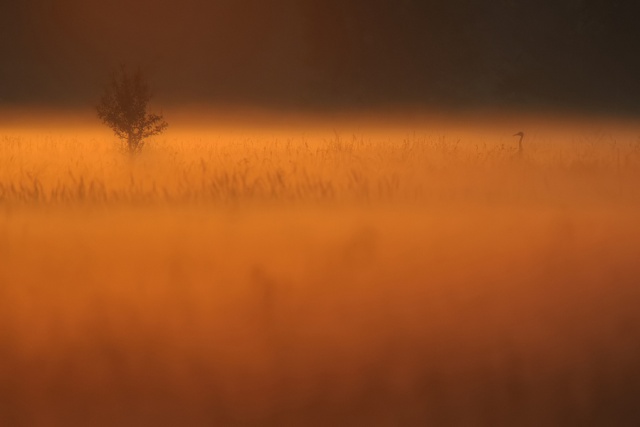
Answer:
[{"left": 0, "top": 124, "right": 640, "bottom": 206}]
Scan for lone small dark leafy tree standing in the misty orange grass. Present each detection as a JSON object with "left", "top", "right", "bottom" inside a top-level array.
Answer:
[{"left": 96, "top": 66, "right": 168, "bottom": 154}]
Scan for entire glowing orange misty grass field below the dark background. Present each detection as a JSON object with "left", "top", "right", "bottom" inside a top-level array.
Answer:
[{"left": 0, "top": 111, "right": 640, "bottom": 426}]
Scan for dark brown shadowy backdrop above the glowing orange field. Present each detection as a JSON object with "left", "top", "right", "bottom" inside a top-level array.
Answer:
[{"left": 0, "top": 0, "right": 640, "bottom": 112}]
